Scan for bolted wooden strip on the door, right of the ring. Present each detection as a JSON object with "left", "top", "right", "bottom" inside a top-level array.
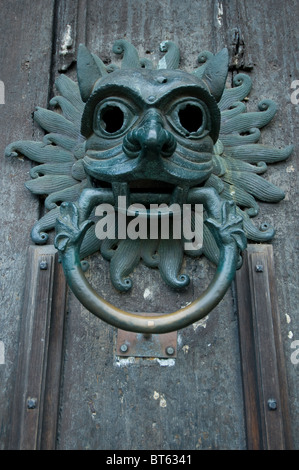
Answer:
[{"left": 236, "top": 245, "right": 292, "bottom": 450}]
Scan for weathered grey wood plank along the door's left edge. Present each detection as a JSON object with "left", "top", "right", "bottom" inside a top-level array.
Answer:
[{"left": 0, "top": 0, "right": 55, "bottom": 449}]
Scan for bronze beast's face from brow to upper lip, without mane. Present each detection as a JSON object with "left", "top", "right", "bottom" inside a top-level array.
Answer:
[{"left": 82, "top": 66, "right": 220, "bottom": 192}]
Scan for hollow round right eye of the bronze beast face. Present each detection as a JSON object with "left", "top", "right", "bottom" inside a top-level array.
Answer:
[{"left": 168, "top": 99, "right": 209, "bottom": 138}]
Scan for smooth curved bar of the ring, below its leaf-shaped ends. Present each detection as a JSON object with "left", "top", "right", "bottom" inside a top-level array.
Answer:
[{"left": 61, "top": 239, "right": 239, "bottom": 334}]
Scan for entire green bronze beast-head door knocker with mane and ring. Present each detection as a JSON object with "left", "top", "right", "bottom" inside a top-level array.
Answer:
[{"left": 6, "top": 40, "right": 292, "bottom": 333}]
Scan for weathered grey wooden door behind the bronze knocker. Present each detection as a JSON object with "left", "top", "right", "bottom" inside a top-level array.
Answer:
[{"left": 0, "top": 0, "right": 299, "bottom": 451}]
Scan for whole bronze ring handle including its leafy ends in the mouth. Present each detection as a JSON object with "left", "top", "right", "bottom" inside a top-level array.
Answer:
[{"left": 55, "top": 188, "right": 246, "bottom": 334}]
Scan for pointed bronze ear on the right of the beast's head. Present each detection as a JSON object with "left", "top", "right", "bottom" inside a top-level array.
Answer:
[{"left": 202, "top": 48, "right": 228, "bottom": 102}]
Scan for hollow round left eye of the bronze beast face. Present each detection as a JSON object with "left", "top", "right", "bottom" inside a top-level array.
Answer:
[{"left": 93, "top": 100, "right": 134, "bottom": 137}]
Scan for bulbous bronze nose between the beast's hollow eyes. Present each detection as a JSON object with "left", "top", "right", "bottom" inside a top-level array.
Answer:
[{"left": 123, "top": 109, "right": 176, "bottom": 160}]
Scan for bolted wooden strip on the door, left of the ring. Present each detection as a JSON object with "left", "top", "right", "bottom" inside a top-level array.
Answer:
[{"left": 10, "top": 246, "right": 66, "bottom": 450}]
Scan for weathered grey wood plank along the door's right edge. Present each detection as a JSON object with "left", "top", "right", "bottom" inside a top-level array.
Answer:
[{"left": 226, "top": 0, "right": 299, "bottom": 448}]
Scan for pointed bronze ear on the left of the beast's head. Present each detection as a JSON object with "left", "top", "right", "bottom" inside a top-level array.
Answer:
[{"left": 77, "top": 44, "right": 107, "bottom": 102}]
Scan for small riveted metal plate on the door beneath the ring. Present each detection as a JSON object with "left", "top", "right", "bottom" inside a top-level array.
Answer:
[{"left": 116, "top": 324, "right": 177, "bottom": 358}]
